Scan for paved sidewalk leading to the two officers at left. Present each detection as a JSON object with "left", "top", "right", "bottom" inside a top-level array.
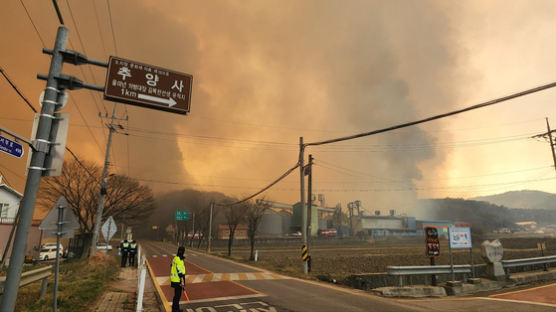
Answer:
[{"left": 90, "top": 267, "right": 162, "bottom": 312}]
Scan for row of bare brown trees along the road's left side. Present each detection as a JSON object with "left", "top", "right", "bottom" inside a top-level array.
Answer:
[{"left": 38, "top": 160, "right": 269, "bottom": 260}]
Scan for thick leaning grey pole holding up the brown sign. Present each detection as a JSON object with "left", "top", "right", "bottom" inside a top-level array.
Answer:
[{"left": 0, "top": 27, "right": 68, "bottom": 312}]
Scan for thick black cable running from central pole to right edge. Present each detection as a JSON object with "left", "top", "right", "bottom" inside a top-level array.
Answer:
[{"left": 304, "top": 82, "right": 556, "bottom": 146}]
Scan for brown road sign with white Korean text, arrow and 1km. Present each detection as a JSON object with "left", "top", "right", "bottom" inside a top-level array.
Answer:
[{"left": 104, "top": 56, "right": 193, "bottom": 114}]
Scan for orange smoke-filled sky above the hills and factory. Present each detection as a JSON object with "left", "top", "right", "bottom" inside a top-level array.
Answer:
[{"left": 0, "top": 0, "right": 556, "bottom": 216}]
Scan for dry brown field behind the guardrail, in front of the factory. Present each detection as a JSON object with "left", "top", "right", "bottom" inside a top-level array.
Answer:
[{"left": 213, "top": 238, "right": 556, "bottom": 278}]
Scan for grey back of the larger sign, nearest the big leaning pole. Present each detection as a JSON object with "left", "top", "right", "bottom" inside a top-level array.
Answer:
[{"left": 39, "top": 196, "right": 79, "bottom": 238}]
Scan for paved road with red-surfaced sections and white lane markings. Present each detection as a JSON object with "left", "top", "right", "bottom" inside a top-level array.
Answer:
[{"left": 139, "top": 242, "right": 556, "bottom": 312}]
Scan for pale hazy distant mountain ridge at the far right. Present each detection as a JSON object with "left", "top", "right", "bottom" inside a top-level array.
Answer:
[{"left": 469, "top": 190, "right": 556, "bottom": 210}]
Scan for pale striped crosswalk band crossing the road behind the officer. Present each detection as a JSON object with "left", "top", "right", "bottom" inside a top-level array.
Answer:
[{"left": 156, "top": 272, "right": 288, "bottom": 285}]
